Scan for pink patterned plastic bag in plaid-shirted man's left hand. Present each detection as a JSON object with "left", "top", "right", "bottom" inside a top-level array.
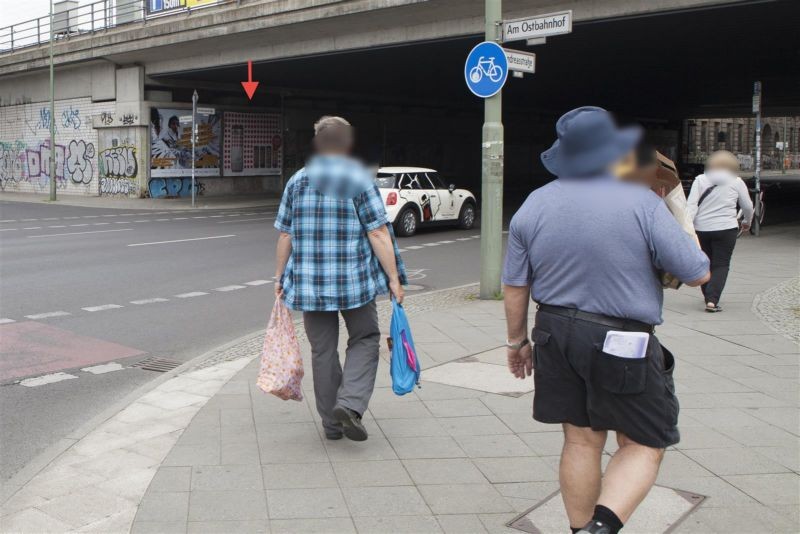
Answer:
[{"left": 256, "top": 298, "right": 303, "bottom": 401}]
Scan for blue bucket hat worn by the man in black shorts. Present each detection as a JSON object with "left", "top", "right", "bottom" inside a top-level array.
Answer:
[{"left": 541, "top": 106, "right": 642, "bottom": 177}]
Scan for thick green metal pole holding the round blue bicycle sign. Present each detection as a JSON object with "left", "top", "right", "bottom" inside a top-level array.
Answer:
[{"left": 480, "top": 0, "right": 503, "bottom": 299}]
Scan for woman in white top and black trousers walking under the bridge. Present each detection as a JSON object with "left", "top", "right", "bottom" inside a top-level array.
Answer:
[{"left": 687, "top": 150, "right": 753, "bottom": 312}]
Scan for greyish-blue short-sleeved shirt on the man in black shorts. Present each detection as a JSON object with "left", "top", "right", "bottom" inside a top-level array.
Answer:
[{"left": 503, "top": 176, "right": 709, "bottom": 324}]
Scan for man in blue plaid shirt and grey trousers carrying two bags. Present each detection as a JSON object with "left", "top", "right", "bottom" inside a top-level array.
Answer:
[{"left": 275, "top": 117, "right": 406, "bottom": 441}]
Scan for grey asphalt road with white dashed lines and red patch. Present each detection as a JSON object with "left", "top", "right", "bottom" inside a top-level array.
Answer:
[{"left": 0, "top": 202, "right": 480, "bottom": 480}]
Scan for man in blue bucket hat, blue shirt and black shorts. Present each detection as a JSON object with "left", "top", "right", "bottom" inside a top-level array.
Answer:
[{"left": 503, "top": 107, "right": 709, "bottom": 534}]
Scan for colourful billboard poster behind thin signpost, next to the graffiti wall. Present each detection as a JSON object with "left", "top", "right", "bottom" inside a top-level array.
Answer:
[{"left": 150, "top": 108, "right": 220, "bottom": 178}]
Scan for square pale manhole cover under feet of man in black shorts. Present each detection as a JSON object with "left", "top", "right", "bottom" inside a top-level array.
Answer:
[{"left": 508, "top": 486, "right": 705, "bottom": 534}]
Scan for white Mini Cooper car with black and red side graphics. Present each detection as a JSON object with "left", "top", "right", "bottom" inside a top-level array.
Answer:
[{"left": 375, "top": 167, "right": 477, "bottom": 237}]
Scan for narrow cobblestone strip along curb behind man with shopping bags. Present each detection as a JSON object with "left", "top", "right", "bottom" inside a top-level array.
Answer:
[{"left": 193, "top": 284, "right": 478, "bottom": 369}]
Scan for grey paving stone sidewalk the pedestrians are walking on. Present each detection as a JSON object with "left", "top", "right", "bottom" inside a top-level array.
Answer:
[{"left": 0, "top": 226, "right": 800, "bottom": 534}]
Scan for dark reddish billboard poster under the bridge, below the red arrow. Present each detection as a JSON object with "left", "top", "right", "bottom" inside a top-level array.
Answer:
[{"left": 223, "top": 111, "right": 283, "bottom": 176}]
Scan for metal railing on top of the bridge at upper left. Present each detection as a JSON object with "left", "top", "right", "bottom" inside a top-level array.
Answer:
[{"left": 0, "top": 0, "right": 232, "bottom": 54}]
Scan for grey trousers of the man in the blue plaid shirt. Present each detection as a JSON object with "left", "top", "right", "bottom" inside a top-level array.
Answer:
[{"left": 303, "top": 300, "right": 381, "bottom": 431}]
